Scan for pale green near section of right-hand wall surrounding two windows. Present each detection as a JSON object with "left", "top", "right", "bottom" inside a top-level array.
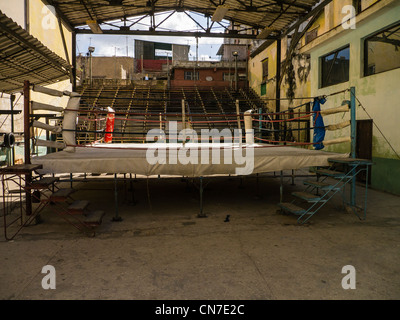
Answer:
[{"left": 309, "top": 1, "right": 400, "bottom": 194}]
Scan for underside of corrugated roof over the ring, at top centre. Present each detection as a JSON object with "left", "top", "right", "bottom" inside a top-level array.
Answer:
[{"left": 52, "top": 0, "right": 319, "bottom": 30}]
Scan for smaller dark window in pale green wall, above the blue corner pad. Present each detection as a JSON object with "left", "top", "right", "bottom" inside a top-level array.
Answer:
[{"left": 320, "top": 46, "right": 350, "bottom": 88}]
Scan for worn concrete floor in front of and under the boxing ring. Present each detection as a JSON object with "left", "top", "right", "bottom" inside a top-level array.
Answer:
[{"left": 0, "top": 172, "right": 400, "bottom": 300}]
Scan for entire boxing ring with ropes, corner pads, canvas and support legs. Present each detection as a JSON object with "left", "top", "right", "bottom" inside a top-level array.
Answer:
[{"left": 0, "top": 82, "right": 355, "bottom": 238}]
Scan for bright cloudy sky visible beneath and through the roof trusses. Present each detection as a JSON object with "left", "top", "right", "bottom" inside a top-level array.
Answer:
[{"left": 76, "top": 12, "right": 230, "bottom": 60}]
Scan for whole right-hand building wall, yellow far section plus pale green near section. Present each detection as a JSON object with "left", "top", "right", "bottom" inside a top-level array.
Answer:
[{"left": 249, "top": 0, "right": 400, "bottom": 194}]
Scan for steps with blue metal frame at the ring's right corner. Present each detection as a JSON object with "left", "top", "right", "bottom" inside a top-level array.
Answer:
[{"left": 278, "top": 158, "right": 372, "bottom": 224}]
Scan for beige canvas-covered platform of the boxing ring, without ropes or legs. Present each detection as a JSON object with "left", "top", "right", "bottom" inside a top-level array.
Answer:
[{"left": 32, "top": 143, "right": 348, "bottom": 178}]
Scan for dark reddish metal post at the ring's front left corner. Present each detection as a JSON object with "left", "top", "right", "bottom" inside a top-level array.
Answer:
[{"left": 24, "top": 80, "right": 32, "bottom": 216}]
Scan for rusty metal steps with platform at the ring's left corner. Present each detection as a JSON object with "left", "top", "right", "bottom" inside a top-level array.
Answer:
[{"left": 0, "top": 164, "right": 105, "bottom": 240}]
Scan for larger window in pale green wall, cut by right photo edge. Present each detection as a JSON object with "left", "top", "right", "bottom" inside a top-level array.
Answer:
[{"left": 364, "top": 24, "right": 400, "bottom": 76}]
